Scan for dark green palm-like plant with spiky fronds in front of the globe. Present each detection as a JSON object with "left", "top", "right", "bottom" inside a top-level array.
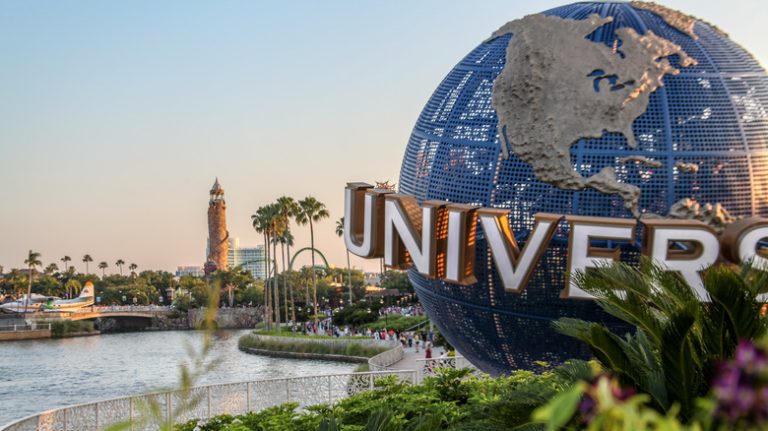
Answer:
[{"left": 555, "top": 261, "right": 768, "bottom": 420}]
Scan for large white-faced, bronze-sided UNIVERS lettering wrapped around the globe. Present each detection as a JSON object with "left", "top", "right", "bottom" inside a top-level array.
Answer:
[{"left": 344, "top": 183, "right": 768, "bottom": 300}]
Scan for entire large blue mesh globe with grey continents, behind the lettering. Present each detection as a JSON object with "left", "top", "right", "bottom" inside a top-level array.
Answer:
[{"left": 399, "top": 2, "right": 768, "bottom": 374}]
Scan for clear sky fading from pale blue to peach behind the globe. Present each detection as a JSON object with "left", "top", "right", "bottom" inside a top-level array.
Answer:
[{"left": 0, "top": 0, "right": 768, "bottom": 271}]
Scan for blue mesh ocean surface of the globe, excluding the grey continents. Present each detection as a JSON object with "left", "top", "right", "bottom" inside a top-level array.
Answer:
[{"left": 399, "top": 2, "right": 768, "bottom": 374}]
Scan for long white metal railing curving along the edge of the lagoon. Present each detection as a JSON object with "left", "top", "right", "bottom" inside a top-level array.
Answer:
[{"left": 0, "top": 371, "right": 417, "bottom": 431}]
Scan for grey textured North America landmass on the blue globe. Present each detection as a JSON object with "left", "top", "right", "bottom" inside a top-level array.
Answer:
[{"left": 489, "top": 14, "right": 697, "bottom": 217}]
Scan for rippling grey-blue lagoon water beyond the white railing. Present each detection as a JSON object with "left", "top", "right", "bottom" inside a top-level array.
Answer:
[{"left": 0, "top": 330, "right": 355, "bottom": 425}]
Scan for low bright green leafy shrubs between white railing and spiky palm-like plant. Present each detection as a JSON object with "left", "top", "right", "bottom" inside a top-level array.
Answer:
[{"left": 175, "top": 369, "right": 584, "bottom": 431}]
